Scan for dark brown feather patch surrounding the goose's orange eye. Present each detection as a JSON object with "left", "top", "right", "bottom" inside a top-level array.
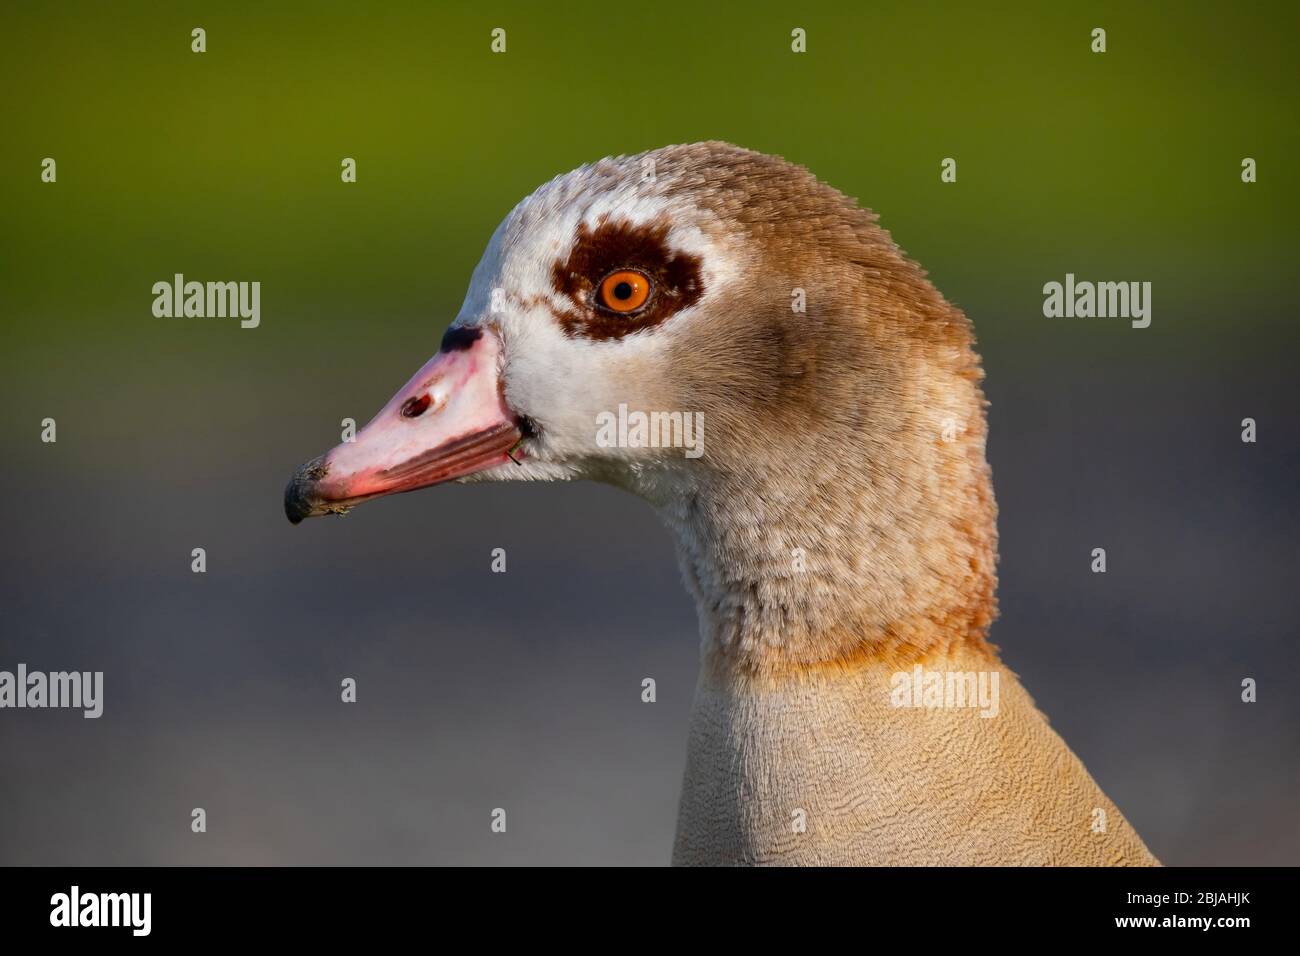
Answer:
[{"left": 551, "top": 217, "right": 705, "bottom": 341}]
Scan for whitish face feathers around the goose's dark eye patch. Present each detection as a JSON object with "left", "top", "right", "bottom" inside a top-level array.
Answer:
[{"left": 455, "top": 153, "right": 741, "bottom": 494}]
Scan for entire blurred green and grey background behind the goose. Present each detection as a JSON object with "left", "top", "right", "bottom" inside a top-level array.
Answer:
[{"left": 0, "top": 3, "right": 1300, "bottom": 865}]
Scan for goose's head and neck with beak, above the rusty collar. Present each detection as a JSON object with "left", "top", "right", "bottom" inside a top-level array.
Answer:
[{"left": 285, "top": 143, "right": 995, "bottom": 670}]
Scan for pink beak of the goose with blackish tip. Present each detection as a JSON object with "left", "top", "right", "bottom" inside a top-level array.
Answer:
[{"left": 285, "top": 326, "right": 524, "bottom": 524}]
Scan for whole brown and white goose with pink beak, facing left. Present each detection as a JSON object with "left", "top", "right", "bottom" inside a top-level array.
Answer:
[{"left": 285, "top": 142, "right": 1157, "bottom": 866}]
